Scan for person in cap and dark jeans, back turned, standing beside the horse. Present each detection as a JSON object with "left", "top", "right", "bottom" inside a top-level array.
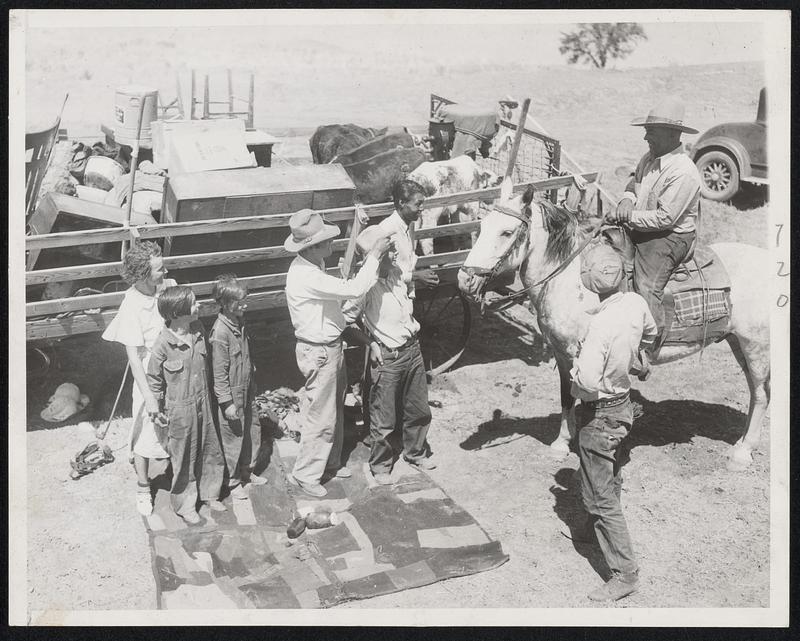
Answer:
[{"left": 571, "top": 245, "right": 656, "bottom": 601}]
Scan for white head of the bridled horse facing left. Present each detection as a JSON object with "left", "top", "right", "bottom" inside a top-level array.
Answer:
[{"left": 458, "top": 180, "right": 534, "bottom": 300}]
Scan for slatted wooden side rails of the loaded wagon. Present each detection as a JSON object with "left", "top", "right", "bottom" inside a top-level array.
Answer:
[{"left": 25, "top": 173, "right": 596, "bottom": 340}]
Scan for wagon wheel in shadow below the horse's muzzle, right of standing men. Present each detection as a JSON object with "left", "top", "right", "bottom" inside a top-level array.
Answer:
[{"left": 414, "top": 284, "right": 472, "bottom": 376}]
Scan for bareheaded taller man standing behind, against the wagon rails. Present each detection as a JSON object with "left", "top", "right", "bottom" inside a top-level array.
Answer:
[{"left": 378, "top": 180, "right": 439, "bottom": 298}]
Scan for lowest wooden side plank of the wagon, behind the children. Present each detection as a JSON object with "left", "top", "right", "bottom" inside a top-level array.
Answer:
[{"left": 25, "top": 290, "right": 286, "bottom": 341}]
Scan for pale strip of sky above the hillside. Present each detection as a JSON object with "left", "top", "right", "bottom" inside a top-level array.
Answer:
[{"left": 20, "top": 10, "right": 775, "bottom": 69}]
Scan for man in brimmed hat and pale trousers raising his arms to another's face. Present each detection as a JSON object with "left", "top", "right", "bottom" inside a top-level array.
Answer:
[{"left": 283, "top": 209, "right": 389, "bottom": 497}]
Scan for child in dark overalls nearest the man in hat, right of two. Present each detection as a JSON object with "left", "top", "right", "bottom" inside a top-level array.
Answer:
[{"left": 209, "top": 274, "right": 267, "bottom": 499}]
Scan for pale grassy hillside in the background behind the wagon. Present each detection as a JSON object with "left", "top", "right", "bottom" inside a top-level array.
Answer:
[{"left": 26, "top": 28, "right": 766, "bottom": 242}]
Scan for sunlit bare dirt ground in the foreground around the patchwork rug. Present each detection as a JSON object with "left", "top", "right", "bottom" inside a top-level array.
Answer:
[{"left": 23, "top": 268, "right": 769, "bottom": 611}]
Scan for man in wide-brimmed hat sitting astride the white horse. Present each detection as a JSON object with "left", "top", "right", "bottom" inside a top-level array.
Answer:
[{"left": 609, "top": 97, "right": 700, "bottom": 343}]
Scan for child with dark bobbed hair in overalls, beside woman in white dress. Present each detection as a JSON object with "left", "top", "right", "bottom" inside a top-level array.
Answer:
[{"left": 147, "top": 286, "right": 226, "bottom": 525}]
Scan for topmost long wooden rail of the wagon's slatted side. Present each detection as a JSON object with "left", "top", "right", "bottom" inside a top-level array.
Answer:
[{"left": 25, "top": 172, "right": 597, "bottom": 251}]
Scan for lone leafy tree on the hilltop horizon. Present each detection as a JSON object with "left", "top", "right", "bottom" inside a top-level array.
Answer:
[{"left": 558, "top": 22, "right": 647, "bottom": 69}]
